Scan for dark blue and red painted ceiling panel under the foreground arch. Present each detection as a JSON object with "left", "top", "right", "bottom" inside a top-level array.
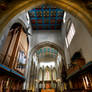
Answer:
[{"left": 29, "top": 5, "right": 64, "bottom": 30}]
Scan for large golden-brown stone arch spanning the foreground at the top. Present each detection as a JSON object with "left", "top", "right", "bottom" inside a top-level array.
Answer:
[{"left": 0, "top": 0, "right": 92, "bottom": 35}]
